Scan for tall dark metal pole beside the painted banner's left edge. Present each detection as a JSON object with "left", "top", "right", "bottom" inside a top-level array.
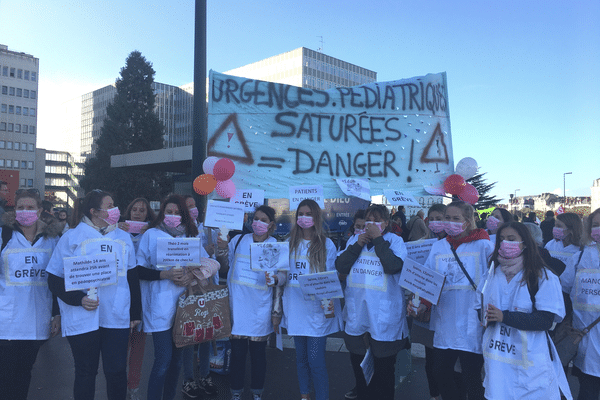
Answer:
[{"left": 192, "top": 0, "right": 207, "bottom": 214}]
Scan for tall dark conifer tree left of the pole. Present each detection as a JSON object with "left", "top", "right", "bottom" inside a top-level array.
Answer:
[{"left": 81, "top": 50, "right": 172, "bottom": 206}]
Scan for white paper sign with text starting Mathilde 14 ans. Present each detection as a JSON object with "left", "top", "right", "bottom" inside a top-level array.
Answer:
[{"left": 63, "top": 253, "right": 117, "bottom": 292}]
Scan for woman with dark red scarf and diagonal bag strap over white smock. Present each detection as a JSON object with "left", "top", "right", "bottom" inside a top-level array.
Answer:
[{"left": 418, "top": 201, "right": 493, "bottom": 400}]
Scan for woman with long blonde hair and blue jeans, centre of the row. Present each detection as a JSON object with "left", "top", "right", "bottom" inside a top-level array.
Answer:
[{"left": 282, "top": 199, "right": 342, "bottom": 400}]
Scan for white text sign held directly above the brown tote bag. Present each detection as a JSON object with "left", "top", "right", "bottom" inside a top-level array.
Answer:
[{"left": 156, "top": 237, "right": 200, "bottom": 268}]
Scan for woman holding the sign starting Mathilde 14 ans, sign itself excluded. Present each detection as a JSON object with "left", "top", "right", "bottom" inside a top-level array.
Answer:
[{"left": 46, "top": 190, "right": 141, "bottom": 400}]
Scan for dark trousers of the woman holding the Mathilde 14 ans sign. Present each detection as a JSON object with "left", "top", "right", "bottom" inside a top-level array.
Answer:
[{"left": 67, "top": 328, "right": 129, "bottom": 400}]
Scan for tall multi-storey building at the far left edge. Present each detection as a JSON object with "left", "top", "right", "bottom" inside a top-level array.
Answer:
[{"left": 0, "top": 44, "right": 39, "bottom": 192}]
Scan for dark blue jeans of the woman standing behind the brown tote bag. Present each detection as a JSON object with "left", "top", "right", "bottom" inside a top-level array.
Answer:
[{"left": 148, "top": 329, "right": 182, "bottom": 400}]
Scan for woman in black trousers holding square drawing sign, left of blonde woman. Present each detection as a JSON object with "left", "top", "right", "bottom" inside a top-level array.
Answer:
[{"left": 217, "top": 205, "right": 287, "bottom": 400}]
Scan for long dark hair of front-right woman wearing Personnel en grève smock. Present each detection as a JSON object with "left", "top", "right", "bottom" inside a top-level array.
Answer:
[{"left": 490, "top": 221, "right": 547, "bottom": 287}]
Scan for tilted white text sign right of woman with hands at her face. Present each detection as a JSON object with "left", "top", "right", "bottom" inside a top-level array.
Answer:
[{"left": 400, "top": 258, "right": 446, "bottom": 304}]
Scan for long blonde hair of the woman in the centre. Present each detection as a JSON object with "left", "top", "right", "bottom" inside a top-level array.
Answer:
[{"left": 290, "top": 199, "right": 327, "bottom": 273}]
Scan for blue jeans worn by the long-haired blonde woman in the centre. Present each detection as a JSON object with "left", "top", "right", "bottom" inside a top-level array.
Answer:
[{"left": 294, "top": 336, "right": 329, "bottom": 400}]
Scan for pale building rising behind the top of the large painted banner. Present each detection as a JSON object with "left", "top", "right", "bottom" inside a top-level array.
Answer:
[{"left": 224, "top": 47, "right": 377, "bottom": 90}]
